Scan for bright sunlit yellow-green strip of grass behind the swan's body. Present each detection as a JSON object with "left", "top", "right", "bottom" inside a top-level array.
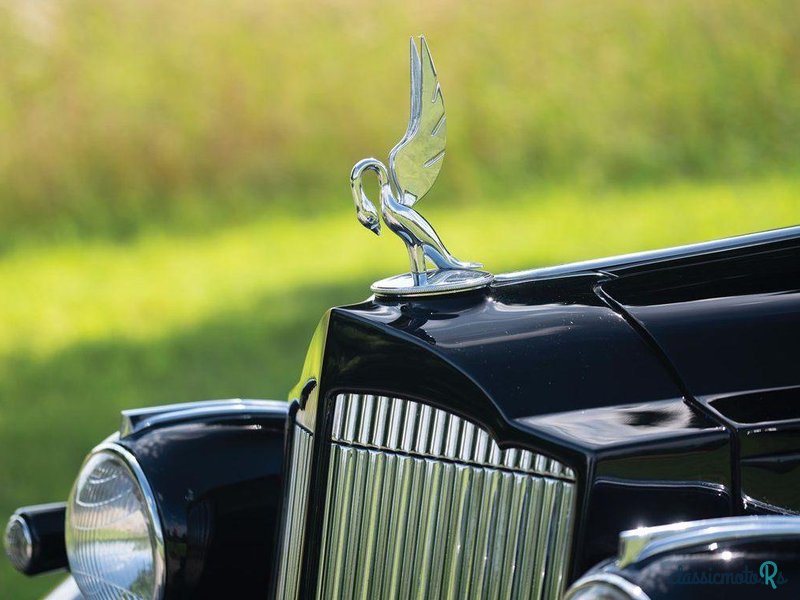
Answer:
[{"left": 0, "top": 173, "right": 800, "bottom": 356}]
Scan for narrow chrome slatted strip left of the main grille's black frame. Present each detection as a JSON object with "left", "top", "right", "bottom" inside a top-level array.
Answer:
[{"left": 275, "top": 424, "right": 314, "bottom": 600}]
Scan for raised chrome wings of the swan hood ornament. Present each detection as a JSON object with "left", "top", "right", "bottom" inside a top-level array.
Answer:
[{"left": 389, "top": 37, "right": 447, "bottom": 206}]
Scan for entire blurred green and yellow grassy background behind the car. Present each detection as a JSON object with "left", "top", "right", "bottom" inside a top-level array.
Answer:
[{"left": 0, "top": 0, "right": 800, "bottom": 600}]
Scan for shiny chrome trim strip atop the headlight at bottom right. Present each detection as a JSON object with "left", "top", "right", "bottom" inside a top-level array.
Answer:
[{"left": 617, "top": 516, "right": 800, "bottom": 568}]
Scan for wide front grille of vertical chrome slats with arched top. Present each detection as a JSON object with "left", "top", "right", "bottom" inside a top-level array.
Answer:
[{"left": 317, "top": 394, "right": 575, "bottom": 599}]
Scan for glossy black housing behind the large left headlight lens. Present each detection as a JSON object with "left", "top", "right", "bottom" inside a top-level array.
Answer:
[{"left": 118, "top": 411, "right": 286, "bottom": 598}]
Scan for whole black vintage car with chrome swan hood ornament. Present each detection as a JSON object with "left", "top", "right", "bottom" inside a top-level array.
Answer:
[{"left": 5, "top": 36, "right": 800, "bottom": 600}]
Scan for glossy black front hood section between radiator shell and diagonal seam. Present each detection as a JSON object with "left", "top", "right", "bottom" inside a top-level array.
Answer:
[{"left": 329, "top": 273, "right": 681, "bottom": 421}]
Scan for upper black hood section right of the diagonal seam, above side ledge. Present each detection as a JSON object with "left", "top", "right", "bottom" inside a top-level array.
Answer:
[{"left": 601, "top": 234, "right": 800, "bottom": 422}]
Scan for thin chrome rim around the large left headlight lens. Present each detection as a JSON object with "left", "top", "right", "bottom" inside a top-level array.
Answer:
[{"left": 64, "top": 441, "right": 167, "bottom": 599}]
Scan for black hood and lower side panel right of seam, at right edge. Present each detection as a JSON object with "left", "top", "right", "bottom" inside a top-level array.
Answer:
[{"left": 603, "top": 233, "right": 800, "bottom": 513}]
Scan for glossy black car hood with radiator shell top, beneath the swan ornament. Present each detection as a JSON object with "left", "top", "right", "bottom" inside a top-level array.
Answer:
[{"left": 293, "top": 228, "right": 800, "bottom": 452}]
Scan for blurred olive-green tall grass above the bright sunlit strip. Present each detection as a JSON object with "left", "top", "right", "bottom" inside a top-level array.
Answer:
[{"left": 0, "top": 0, "right": 800, "bottom": 241}]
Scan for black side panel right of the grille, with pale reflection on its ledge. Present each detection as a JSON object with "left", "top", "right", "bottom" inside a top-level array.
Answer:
[{"left": 519, "top": 400, "right": 733, "bottom": 572}]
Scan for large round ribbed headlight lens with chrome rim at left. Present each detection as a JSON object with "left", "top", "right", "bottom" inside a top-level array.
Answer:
[{"left": 65, "top": 444, "right": 165, "bottom": 600}]
